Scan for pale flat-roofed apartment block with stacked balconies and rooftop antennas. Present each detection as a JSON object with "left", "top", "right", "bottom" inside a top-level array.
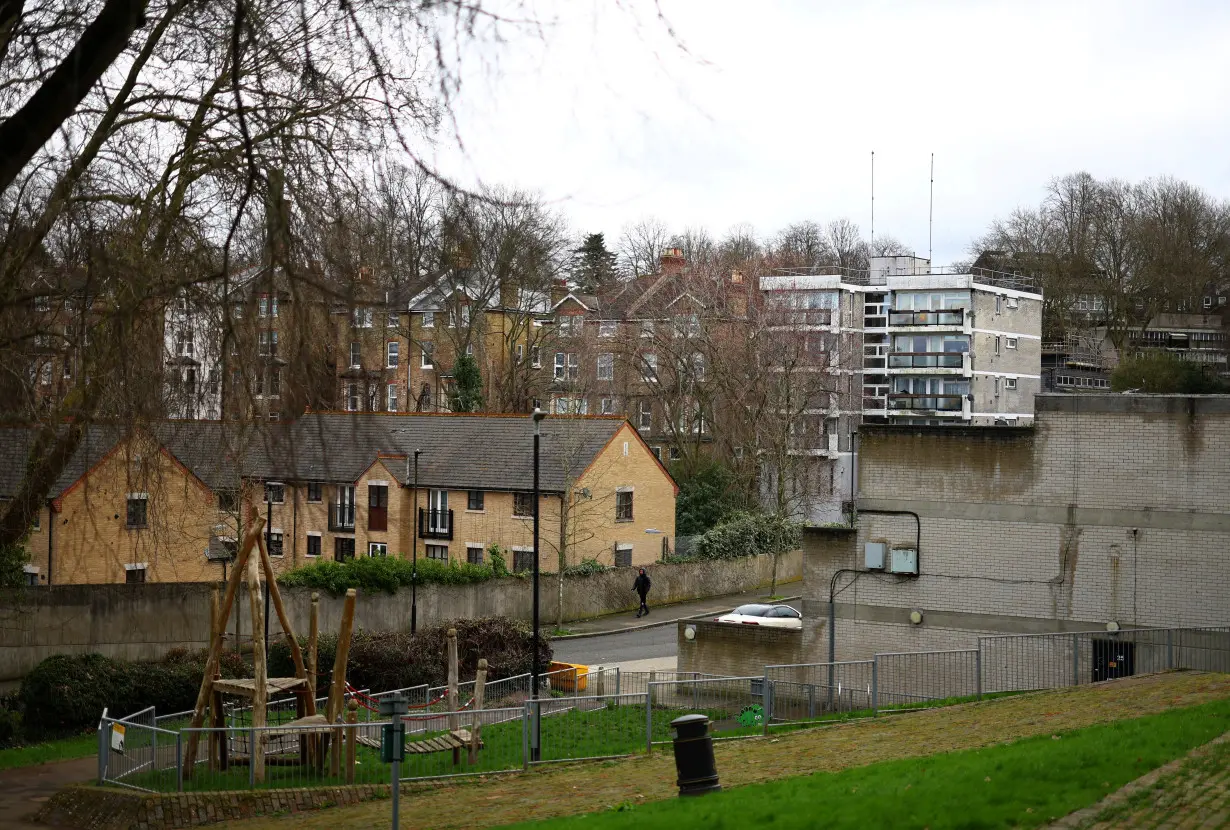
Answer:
[{"left": 760, "top": 256, "right": 1042, "bottom": 521}]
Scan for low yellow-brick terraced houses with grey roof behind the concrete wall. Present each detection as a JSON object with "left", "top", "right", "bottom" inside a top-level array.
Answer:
[{"left": 0, "top": 413, "right": 677, "bottom": 585}]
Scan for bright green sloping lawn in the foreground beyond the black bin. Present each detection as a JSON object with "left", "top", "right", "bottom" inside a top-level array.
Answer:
[{"left": 499, "top": 700, "right": 1230, "bottom": 830}]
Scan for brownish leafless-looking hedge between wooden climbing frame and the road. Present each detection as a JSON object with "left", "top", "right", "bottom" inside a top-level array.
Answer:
[{"left": 269, "top": 617, "right": 551, "bottom": 694}]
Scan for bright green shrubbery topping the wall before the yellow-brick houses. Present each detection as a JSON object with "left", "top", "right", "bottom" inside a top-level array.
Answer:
[{"left": 278, "top": 556, "right": 496, "bottom": 596}]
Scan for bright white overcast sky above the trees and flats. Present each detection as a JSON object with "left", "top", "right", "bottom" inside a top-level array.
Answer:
[{"left": 439, "top": 0, "right": 1230, "bottom": 264}]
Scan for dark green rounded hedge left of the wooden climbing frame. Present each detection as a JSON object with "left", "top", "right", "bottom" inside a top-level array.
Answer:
[{"left": 18, "top": 649, "right": 251, "bottom": 738}]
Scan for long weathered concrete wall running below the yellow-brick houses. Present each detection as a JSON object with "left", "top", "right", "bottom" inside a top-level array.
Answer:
[{"left": 0, "top": 551, "right": 802, "bottom": 685}]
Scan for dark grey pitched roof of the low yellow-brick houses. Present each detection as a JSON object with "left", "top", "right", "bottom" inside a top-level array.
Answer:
[{"left": 0, "top": 412, "right": 626, "bottom": 498}]
